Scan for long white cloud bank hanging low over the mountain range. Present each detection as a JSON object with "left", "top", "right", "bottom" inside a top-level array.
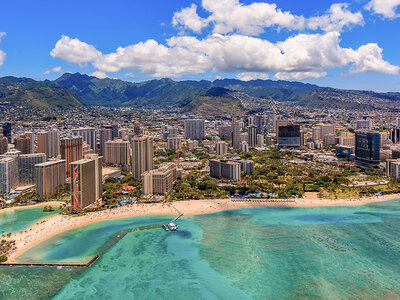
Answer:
[{"left": 51, "top": 32, "right": 399, "bottom": 80}]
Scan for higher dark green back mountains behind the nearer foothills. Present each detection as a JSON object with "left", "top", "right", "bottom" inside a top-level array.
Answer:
[{"left": 55, "top": 73, "right": 320, "bottom": 107}]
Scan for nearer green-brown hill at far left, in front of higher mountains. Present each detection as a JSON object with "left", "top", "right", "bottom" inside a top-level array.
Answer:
[{"left": 0, "top": 76, "right": 82, "bottom": 108}]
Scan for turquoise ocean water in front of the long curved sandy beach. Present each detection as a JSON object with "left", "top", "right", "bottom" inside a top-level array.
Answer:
[{"left": 0, "top": 200, "right": 400, "bottom": 299}]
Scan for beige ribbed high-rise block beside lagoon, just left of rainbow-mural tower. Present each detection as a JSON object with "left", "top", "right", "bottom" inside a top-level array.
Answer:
[{"left": 35, "top": 159, "right": 66, "bottom": 198}]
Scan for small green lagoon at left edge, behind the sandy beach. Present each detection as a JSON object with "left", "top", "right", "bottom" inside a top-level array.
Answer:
[{"left": 0, "top": 206, "right": 60, "bottom": 234}]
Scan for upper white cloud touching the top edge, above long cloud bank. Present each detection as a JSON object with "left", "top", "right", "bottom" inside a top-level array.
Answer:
[{"left": 172, "top": 0, "right": 364, "bottom": 36}]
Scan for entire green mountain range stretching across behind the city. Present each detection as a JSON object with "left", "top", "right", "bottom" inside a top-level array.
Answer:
[{"left": 0, "top": 73, "right": 400, "bottom": 113}]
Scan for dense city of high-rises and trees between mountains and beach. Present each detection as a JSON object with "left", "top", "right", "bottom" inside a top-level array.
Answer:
[{"left": 0, "top": 93, "right": 400, "bottom": 213}]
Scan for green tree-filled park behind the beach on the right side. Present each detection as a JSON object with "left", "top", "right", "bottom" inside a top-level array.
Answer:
[{"left": 231, "top": 149, "right": 400, "bottom": 198}]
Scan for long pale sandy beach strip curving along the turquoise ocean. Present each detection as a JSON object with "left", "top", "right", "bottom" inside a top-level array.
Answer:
[{"left": 0, "top": 193, "right": 400, "bottom": 263}]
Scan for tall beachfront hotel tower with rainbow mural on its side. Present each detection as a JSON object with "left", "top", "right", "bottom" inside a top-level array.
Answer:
[{"left": 70, "top": 154, "right": 103, "bottom": 210}]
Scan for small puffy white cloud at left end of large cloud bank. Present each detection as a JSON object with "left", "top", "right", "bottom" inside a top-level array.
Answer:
[{"left": 50, "top": 35, "right": 101, "bottom": 63}]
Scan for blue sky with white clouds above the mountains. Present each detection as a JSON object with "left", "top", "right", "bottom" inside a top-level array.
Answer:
[{"left": 0, "top": 0, "right": 400, "bottom": 91}]
